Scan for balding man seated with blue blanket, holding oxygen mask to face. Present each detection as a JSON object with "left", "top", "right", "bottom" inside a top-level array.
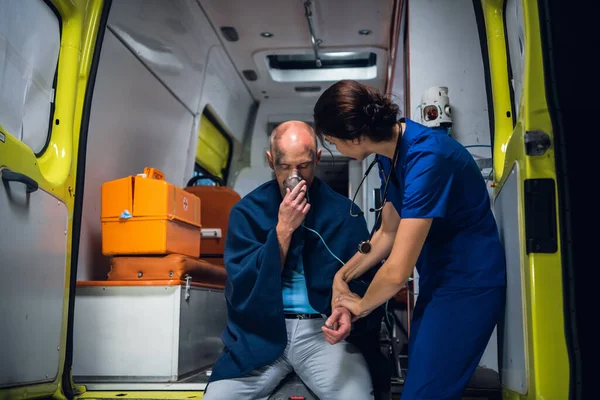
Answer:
[{"left": 204, "top": 121, "right": 390, "bottom": 400}]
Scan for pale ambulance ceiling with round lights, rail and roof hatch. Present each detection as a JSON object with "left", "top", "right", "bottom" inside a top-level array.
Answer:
[{"left": 198, "top": 0, "right": 394, "bottom": 101}]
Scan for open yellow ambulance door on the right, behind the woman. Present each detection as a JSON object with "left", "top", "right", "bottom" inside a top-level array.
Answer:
[{"left": 474, "top": 0, "right": 576, "bottom": 399}]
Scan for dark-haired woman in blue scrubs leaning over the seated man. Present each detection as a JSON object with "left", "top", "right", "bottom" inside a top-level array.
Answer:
[{"left": 314, "top": 80, "right": 506, "bottom": 400}]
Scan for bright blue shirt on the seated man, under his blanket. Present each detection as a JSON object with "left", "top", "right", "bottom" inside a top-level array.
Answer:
[{"left": 281, "top": 257, "right": 319, "bottom": 314}]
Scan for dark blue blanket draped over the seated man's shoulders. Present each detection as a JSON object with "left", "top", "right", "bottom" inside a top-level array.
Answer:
[{"left": 210, "top": 178, "right": 389, "bottom": 382}]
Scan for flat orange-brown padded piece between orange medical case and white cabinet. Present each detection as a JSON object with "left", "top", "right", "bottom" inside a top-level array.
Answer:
[{"left": 108, "top": 254, "right": 227, "bottom": 289}]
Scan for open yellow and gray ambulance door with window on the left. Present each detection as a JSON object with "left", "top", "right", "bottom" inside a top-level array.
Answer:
[{"left": 0, "top": 0, "right": 110, "bottom": 400}]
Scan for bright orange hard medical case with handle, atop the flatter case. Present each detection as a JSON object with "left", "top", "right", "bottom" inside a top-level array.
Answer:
[{"left": 101, "top": 168, "right": 202, "bottom": 257}]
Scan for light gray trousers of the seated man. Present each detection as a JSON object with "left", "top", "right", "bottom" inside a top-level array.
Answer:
[{"left": 204, "top": 319, "right": 373, "bottom": 400}]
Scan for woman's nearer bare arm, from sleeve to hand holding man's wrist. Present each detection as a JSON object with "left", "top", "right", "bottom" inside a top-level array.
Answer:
[{"left": 333, "top": 218, "right": 432, "bottom": 318}]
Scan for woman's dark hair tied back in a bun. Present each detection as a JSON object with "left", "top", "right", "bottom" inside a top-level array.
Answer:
[{"left": 313, "top": 80, "right": 400, "bottom": 143}]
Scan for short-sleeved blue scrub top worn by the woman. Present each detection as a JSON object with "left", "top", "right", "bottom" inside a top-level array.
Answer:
[{"left": 378, "top": 119, "right": 506, "bottom": 296}]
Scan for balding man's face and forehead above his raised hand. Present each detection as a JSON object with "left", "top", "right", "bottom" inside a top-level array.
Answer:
[{"left": 267, "top": 128, "right": 321, "bottom": 197}]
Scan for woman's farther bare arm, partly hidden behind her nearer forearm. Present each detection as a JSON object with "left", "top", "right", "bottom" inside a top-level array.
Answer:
[{"left": 336, "top": 203, "right": 400, "bottom": 283}]
